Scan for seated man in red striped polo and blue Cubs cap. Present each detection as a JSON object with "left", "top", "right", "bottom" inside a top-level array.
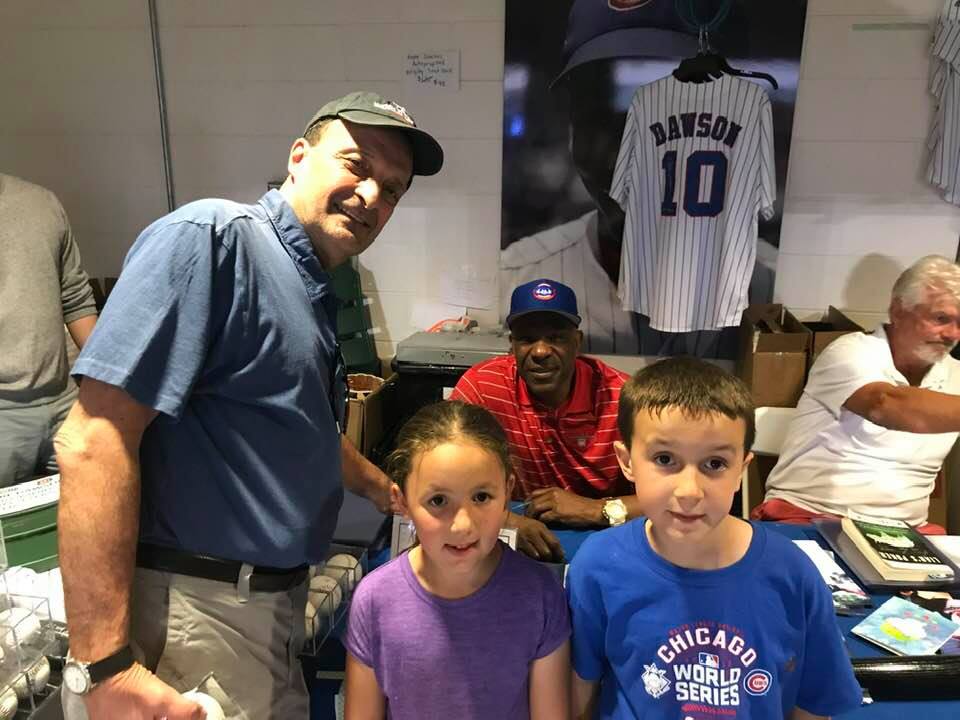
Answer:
[{"left": 451, "top": 279, "right": 640, "bottom": 560}]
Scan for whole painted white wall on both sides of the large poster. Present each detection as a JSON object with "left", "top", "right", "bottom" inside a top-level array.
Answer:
[{"left": 0, "top": 0, "right": 960, "bottom": 356}]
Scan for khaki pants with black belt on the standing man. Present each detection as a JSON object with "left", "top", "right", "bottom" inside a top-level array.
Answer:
[{"left": 62, "top": 568, "right": 310, "bottom": 720}]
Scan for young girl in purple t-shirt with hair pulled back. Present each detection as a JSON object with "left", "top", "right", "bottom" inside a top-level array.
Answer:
[{"left": 344, "top": 401, "right": 570, "bottom": 720}]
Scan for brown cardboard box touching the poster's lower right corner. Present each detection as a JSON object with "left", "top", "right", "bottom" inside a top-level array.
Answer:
[{"left": 737, "top": 303, "right": 813, "bottom": 407}]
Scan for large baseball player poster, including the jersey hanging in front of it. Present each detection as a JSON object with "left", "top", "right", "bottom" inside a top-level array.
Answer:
[{"left": 500, "top": 0, "right": 806, "bottom": 357}]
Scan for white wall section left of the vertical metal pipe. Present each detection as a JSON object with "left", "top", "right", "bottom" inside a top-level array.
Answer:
[{"left": 0, "top": 0, "right": 166, "bottom": 276}]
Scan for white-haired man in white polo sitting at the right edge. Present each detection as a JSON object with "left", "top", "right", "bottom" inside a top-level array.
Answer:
[{"left": 753, "top": 255, "right": 960, "bottom": 533}]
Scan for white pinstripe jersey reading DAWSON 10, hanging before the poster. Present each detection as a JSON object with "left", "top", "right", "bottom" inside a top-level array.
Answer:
[{"left": 610, "top": 75, "right": 776, "bottom": 332}]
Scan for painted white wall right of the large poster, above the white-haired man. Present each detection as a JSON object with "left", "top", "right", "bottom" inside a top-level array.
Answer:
[{"left": 774, "top": 0, "right": 960, "bottom": 328}]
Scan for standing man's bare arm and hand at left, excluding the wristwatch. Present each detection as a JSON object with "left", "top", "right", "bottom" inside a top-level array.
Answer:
[{"left": 54, "top": 378, "right": 203, "bottom": 720}]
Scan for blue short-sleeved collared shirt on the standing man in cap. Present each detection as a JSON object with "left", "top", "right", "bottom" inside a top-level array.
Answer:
[{"left": 74, "top": 191, "right": 345, "bottom": 567}]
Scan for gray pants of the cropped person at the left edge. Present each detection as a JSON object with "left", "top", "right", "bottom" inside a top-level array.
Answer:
[{"left": 0, "top": 382, "right": 77, "bottom": 487}]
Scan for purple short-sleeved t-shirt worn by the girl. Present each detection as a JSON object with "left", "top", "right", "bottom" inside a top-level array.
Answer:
[{"left": 343, "top": 546, "right": 570, "bottom": 720}]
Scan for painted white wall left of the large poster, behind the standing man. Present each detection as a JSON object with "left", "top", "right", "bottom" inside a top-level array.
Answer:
[{"left": 0, "top": 0, "right": 504, "bottom": 356}]
